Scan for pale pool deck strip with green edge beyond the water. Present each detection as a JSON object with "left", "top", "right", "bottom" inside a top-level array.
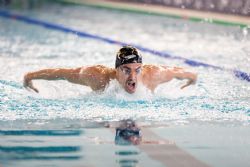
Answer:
[{"left": 62, "top": 0, "right": 250, "bottom": 28}]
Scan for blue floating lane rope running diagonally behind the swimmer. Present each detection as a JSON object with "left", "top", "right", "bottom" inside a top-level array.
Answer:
[{"left": 0, "top": 10, "right": 250, "bottom": 82}]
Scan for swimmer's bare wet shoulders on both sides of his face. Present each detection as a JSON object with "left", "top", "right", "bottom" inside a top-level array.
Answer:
[{"left": 78, "top": 65, "right": 174, "bottom": 91}]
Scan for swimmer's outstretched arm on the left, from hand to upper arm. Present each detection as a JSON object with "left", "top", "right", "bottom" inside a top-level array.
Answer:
[{"left": 23, "top": 68, "right": 82, "bottom": 93}]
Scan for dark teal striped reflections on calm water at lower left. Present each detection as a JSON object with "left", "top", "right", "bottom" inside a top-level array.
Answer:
[{"left": 0, "top": 130, "right": 83, "bottom": 164}]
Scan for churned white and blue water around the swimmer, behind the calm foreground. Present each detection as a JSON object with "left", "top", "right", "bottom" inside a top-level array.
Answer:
[{"left": 0, "top": 3, "right": 250, "bottom": 123}]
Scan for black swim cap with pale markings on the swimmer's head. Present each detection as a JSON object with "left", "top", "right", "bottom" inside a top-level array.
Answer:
[{"left": 115, "top": 46, "right": 142, "bottom": 68}]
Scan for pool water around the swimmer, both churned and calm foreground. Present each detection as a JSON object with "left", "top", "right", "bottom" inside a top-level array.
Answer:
[{"left": 0, "top": 1, "right": 250, "bottom": 167}]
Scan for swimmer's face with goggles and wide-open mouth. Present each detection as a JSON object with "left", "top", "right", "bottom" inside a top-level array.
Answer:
[{"left": 116, "top": 63, "right": 142, "bottom": 94}]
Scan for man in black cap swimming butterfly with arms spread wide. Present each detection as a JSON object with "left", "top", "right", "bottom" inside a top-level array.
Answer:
[{"left": 23, "top": 46, "right": 197, "bottom": 94}]
